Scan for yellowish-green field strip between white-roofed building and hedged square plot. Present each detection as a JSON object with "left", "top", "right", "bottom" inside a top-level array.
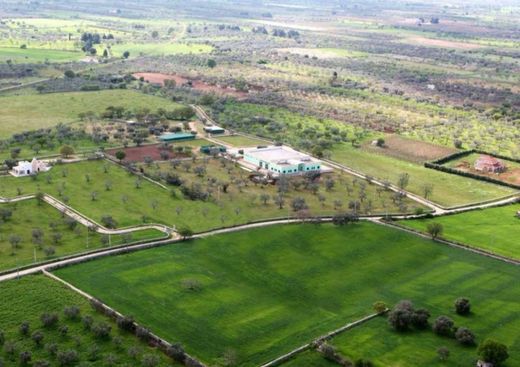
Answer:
[{"left": 331, "top": 144, "right": 515, "bottom": 207}]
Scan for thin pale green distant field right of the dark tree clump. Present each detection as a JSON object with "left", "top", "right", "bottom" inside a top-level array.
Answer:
[{"left": 112, "top": 43, "right": 213, "bottom": 57}]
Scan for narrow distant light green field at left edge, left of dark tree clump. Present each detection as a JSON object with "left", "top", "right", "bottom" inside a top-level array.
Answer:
[{"left": 0, "top": 47, "right": 84, "bottom": 64}]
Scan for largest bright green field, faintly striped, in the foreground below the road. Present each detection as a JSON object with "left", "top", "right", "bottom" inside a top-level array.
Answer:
[{"left": 52, "top": 223, "right": 520, "bottom": 366}]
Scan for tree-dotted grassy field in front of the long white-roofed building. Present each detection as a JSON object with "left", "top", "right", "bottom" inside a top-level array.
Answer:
[{"left": 0, "top": 158, "right": 420, "bottom": 231}]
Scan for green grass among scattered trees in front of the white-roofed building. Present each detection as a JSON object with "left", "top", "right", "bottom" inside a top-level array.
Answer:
[{"left": 0, "top": 161, "right": 422, "bottom": 231}]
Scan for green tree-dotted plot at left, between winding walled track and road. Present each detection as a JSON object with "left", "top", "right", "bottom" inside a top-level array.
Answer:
[{"left": 0, "top": 200, "right": 164, "bottom": 270}]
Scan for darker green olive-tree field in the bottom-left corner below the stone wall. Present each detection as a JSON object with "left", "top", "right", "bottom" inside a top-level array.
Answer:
[{"left": 0, "top": 275, "right": 172, "bottom": 367}]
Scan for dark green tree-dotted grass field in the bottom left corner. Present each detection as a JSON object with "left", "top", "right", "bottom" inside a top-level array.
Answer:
[{"left": 0, "top": 275, "right": 175, "bottom": 366}]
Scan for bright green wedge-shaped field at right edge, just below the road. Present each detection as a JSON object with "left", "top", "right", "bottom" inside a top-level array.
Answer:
[{"left": 400, "top": 204, "right": 520, "bottom": 259}]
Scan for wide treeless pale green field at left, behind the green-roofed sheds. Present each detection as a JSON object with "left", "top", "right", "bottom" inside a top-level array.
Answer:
[{"left": 0, "top": 90, "right": 179, "bottom": 138}]
